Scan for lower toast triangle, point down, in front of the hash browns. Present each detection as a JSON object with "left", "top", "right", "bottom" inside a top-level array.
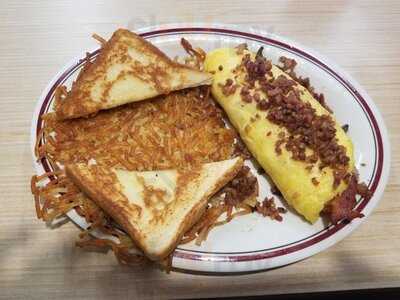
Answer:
[{"left": 66, "top": 157, "right": 243, "bottom": 261}]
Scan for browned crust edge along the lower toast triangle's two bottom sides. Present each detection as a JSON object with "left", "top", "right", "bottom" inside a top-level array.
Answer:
[{"left": 65, "top": 158, "right": 243, "bottom": 261}]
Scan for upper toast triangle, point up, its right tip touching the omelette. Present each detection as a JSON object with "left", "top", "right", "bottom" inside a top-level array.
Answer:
[{"left": 55, "top": 29, "right": 212, "bottom": 119}]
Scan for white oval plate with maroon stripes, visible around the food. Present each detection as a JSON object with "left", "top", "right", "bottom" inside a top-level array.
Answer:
[{"left": 31, "top": 24, "right": 390, "bottom": 273}]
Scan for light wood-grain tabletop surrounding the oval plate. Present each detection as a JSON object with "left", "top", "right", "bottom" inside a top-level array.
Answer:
[{"left": 0, "top": 0, "right": 400, "bottom": 299}]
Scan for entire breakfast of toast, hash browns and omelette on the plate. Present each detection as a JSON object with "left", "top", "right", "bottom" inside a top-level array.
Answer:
[{"left": 31, "top": 30, "right": 368, "bottom": 266}]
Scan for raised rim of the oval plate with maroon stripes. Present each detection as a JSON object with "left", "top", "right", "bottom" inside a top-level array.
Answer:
[{"left": 31, "top": 23, "right": 391, "bottom": 272}]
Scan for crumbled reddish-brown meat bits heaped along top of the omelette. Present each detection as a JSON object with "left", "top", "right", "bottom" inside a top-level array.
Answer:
[{"left": 236, "top": 49, "right": 349, "bottom": 187}]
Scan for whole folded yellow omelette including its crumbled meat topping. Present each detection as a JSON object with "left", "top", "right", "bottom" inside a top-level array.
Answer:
[{"left": 205, "top": 46, "right": 364, "bottom": 223}]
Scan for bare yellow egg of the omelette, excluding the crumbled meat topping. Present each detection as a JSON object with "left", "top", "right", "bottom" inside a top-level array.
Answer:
[{"left": 205, "top": 48, "right": 354, "bottom": 223}]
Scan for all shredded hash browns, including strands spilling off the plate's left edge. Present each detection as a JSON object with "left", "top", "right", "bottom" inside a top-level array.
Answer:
[{"left": 31, "top": 83, "right": 251, "bottom": 264}]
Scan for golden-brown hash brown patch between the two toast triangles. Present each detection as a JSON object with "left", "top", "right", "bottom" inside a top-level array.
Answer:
[{"left": 38, "top": 89, "right": 235, "bottom": 171}]
